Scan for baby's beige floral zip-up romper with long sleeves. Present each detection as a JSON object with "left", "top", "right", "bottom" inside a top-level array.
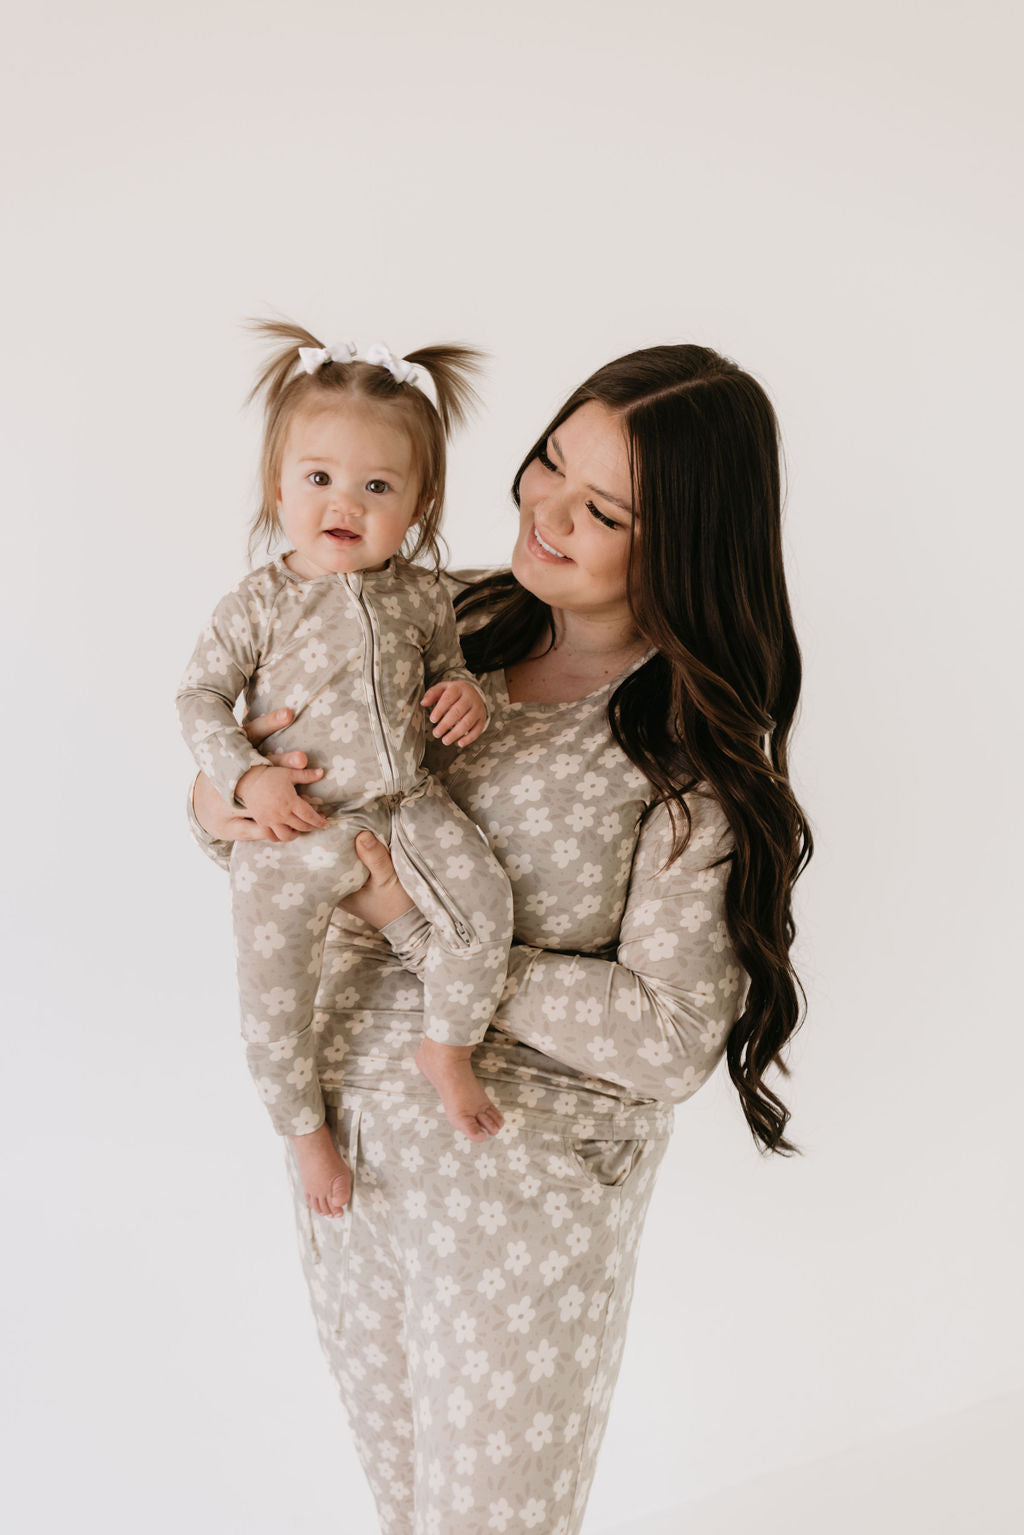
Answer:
[{"left": 177, "top": 556, "right": 511, "bottom": 1134}]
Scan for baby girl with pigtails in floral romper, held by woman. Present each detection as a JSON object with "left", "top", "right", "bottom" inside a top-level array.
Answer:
[{"left": 178, "top": 321, "right": 511, "bottom": 1214}]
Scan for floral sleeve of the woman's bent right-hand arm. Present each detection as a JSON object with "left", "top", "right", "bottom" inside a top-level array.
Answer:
[{"left": 385, "top": 792, "right": 746, "bottom": 1104}]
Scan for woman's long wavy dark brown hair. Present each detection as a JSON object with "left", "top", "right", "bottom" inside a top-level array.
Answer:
[{"left": 456, "top": 345, "right": 814, "bottom": 1154}]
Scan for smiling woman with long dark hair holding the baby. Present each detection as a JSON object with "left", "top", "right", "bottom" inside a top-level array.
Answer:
[{"left": 195, "top": 345, "right": 811, "bottom": 1535}]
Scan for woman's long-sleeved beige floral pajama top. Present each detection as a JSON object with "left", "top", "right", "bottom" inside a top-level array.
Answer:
[{"left": 192, "top": 573, "right": 746, "bottom": 1137}]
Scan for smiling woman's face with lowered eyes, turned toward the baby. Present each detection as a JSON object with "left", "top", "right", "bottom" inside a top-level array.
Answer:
[{"left": 511, "top": 401, "right": 633, "bottom": 619}]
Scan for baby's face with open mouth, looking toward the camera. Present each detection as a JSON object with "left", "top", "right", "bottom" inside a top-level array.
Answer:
[{"left": 278, "top": 401, "right": 419, "bottom": 579}]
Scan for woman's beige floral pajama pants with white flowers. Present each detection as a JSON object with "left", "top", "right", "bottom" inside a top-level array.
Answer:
[{"left": 286, "top": 1088, "right": 668, "bottom": 1535}]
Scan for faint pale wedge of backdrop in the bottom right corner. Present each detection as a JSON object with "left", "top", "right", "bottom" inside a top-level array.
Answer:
[{"left": 586, "top": 1394, "right": 1024, "bottom": 1535}]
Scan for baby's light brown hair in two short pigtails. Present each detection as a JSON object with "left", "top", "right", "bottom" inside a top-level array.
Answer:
[{"left": 247, "top": 319, "right": 485, "bottom": 574}]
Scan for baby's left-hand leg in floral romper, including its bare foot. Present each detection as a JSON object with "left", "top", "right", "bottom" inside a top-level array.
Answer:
[{"left": 232, "top": 818, "right": 365, "bottom": 1214}]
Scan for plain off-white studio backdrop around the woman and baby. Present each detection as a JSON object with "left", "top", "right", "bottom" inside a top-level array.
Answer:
[{"left": 2, "top": 0, "right": 1024, "bottom": 1535}]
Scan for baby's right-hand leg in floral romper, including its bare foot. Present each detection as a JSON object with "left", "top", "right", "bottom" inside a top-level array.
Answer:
[{"left": 391, "top": 780, "right": 511, "bottom": 1141}]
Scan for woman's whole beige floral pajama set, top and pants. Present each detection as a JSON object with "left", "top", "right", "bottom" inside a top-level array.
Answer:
[{"left": 193, "top": 571, "right": 746, "bottom": 1535}]
